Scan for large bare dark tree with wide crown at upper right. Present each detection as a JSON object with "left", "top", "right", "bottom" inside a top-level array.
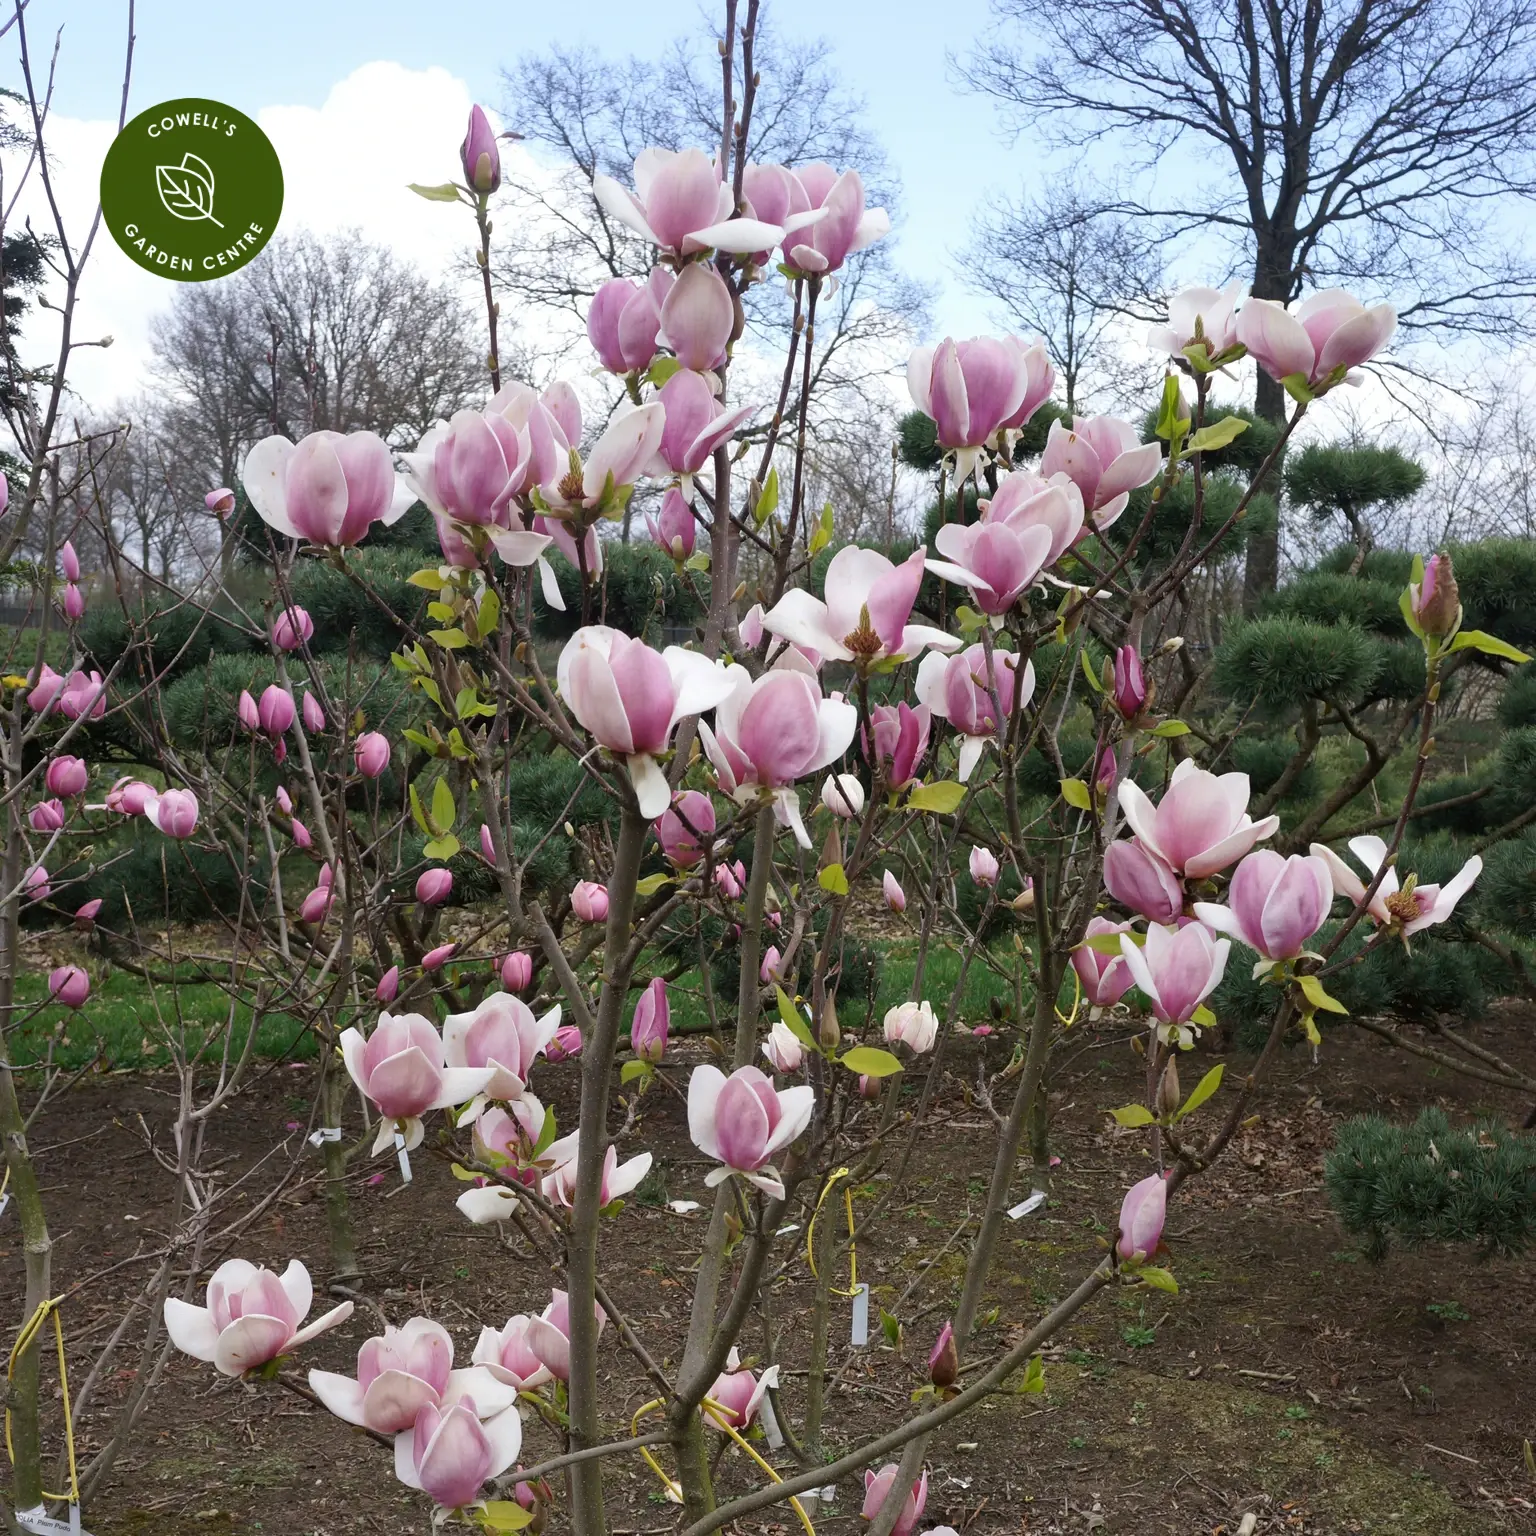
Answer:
[{"left": 962, "top": 0, "right": 1536, "bottom": 605}]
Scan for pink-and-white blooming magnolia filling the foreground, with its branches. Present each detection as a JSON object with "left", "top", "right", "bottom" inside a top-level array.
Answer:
[{"left": 0, "top": 0, "right": 1524, "bottom": 1536}]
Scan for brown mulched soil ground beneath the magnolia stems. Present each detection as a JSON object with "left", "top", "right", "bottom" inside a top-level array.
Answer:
[{"left": 0, "top": 1006, "right": 1536, "bottom": 1536}]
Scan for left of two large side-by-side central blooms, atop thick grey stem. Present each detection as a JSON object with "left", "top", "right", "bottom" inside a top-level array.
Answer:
[{"left": 556, "top": 624, "right": 733, "bottom": 817}]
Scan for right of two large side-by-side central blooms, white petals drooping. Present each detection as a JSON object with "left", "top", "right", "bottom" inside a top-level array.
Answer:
[{"left": 699, "top": 653, "right": 859, "bottom": 848}]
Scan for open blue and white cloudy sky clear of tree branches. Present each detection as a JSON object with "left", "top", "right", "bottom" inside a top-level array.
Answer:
[{"left": 14, "top": 0, "right": 1038, "bottom": 404}]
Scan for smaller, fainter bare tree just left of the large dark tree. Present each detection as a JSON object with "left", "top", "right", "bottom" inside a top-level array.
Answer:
[{"left": 962, "top": 181, "right": 1161, "bottom": 412}]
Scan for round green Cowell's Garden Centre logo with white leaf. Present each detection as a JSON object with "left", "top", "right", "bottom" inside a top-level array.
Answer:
[{"left": 101, "top": 97, "right": 283, "bottom": 283}]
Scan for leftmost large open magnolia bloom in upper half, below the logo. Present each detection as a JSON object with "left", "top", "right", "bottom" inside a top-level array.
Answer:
[{"left": 240, "top": 432, "right": 416, "bottom": 547}]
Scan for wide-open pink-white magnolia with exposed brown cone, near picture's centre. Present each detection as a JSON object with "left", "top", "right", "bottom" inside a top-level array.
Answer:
[{"left": 763, "top": 544, "right": 960, "bottom": 670}]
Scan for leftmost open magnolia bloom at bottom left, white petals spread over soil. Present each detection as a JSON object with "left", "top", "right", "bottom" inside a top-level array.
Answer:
[{"left": 164, "top": 1258, "right": 352, "bottom": 1376}]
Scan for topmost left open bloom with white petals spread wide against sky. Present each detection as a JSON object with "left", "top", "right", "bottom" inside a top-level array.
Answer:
[{"left": 591, "top": 149, "right": 783, "bottom": 257}]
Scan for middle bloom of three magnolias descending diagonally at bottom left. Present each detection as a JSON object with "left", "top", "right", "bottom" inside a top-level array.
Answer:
[{"left": 309, "top": 1318, "right": 516, "bottom": 1435}]
